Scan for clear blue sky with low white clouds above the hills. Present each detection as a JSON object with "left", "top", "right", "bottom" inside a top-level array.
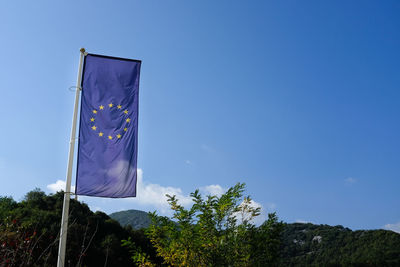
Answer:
[{"left": 0, "top": 0, "right": 400, "bottom": 231}]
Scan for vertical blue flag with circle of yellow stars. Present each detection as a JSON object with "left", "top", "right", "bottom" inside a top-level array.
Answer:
[{"left": 75, "top": 54, "right": 141, "bottom": 198}]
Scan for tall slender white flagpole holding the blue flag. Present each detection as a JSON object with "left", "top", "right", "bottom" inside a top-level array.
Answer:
[{"left": 57, "top": 48, "right": 86, "bottom": 267}]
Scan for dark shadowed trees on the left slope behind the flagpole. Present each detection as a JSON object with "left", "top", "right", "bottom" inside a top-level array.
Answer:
[{"left": 0, "top": 189, "right": 156, "bottom": 266}]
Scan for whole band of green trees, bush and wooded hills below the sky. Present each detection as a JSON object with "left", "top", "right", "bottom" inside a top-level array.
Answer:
[{"left": 0, "top": 187, "right": 400, "bottom": 266}]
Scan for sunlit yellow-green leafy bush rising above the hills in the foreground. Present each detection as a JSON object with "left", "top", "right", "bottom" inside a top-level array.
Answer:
[{"left": 147, "top": 183, "right": 282, "bottom": 266}]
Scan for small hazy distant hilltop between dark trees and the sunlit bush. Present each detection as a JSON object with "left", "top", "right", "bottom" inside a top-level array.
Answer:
[{"left": 109, "top": 210, "right": 151, "bottom": 230}]
